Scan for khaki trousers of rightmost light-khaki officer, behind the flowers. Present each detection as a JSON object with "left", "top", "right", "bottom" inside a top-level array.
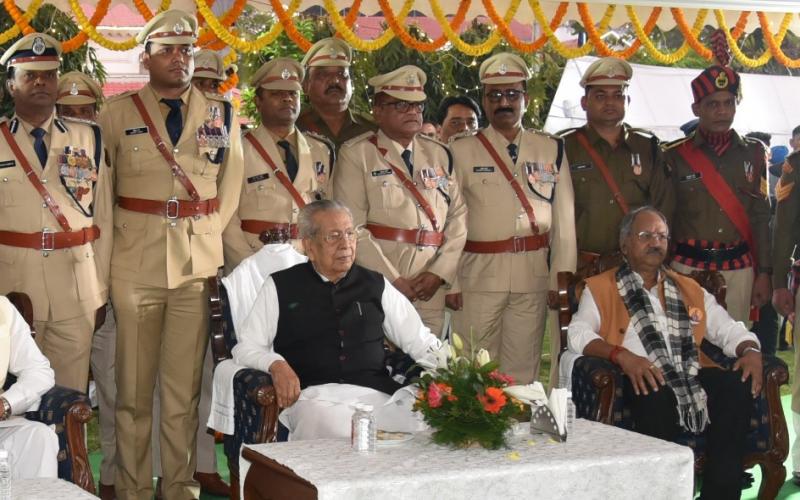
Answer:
[{"left": 453, "top": 291, "right": 547, "bottom": 384}]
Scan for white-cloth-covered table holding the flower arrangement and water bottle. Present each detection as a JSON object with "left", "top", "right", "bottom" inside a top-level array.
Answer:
[{"left": 239, "top": 419, "right": 694, "bottom": 500}]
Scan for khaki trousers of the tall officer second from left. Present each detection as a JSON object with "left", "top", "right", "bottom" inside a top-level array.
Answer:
[{"left": 112, "top": 278, "right": 208, "bottom": 500}]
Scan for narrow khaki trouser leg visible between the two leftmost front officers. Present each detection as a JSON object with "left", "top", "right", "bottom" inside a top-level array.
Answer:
[{"left": 91, "top": 303, "right": 117, "bottom": 485}]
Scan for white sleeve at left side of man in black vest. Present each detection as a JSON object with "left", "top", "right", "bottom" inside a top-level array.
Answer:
[{"left": 232, "top": 276, "right": 284, "bottom": 373}]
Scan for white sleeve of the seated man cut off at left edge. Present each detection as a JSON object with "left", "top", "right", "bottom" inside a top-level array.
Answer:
[{"left": 3, "top": 307, "right": 56, "bottom": 415}]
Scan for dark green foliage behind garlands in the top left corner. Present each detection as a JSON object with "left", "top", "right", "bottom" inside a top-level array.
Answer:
[{"left": 0, "top": 4, "right": 107, "bottom": 116}]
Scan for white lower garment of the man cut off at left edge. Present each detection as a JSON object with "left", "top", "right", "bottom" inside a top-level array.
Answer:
[{"left": 0, "top": 417, "right": 58, "bottom": 479}]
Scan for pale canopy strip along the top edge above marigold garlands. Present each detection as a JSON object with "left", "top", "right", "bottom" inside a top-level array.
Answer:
[{"left": 10, "top": 0, "right": 800, "bottom": 32}]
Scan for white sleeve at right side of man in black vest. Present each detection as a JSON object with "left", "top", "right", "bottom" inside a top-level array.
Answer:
[{"left": 381, "top": 277, "right": 441, "bottom": 362}]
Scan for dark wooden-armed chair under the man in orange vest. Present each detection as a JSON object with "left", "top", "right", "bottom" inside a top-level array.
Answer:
[{"left": 557, "top": 271, "right": 789, "bottom": 499}]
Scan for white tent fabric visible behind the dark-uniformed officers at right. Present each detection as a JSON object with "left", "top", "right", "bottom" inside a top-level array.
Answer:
[{"left": 544, "top": 57, "right": 800, "bottom": 146}]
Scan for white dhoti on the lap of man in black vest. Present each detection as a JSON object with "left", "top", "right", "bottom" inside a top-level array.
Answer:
[{"left": 278, "top": 384, "right": 425, "bottom": 441}]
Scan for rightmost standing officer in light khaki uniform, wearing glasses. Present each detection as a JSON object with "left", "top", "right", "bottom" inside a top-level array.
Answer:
[{"left": 449, "top": 53, "right": 576, "bottom": 384}]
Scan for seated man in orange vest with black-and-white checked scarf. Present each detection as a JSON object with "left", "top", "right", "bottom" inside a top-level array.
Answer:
[{"left": 568, "top": 206, "right": 762, "bottom": 499}]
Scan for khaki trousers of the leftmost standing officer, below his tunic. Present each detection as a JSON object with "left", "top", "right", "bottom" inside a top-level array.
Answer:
[{"left": 33, "top": 312, "right": 95, "bottom": 393}]
